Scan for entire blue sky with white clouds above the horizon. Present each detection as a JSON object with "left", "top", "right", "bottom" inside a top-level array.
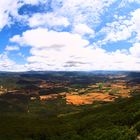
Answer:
[{"left": 0, "top": 0, "right": 140, "bottom": 71}]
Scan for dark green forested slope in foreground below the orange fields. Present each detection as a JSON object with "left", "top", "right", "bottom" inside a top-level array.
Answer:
[{"left": 0, "top": 93, "right": 140, "bottom": 140}]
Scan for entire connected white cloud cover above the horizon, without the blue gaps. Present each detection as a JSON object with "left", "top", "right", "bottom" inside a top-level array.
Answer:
[{"left": 0, "top": 0, "right": 140, "bottom": 70}]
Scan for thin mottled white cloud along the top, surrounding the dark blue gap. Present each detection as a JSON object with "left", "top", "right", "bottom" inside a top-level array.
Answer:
[{"left": 0, "top": 0, "right": 114, "bottom": 30}]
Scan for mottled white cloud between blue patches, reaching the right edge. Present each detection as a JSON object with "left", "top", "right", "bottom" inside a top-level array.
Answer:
[{"left": 97, "top": 8, "right": 140, "bottom": 46}]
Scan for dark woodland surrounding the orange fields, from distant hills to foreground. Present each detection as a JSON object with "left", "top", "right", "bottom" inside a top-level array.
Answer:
[{"left": 0, "top": 72, "right": 140, "bottom": 140}]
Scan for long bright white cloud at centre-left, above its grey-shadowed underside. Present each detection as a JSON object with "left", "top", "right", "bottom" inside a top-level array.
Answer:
[{"left": 10, "top": 28, "right": 89, "bottom": 49}]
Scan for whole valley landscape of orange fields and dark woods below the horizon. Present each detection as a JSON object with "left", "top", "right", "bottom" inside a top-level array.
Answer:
[{"left": 0, "top": 71, "right": 140, "bottom": 140}]
